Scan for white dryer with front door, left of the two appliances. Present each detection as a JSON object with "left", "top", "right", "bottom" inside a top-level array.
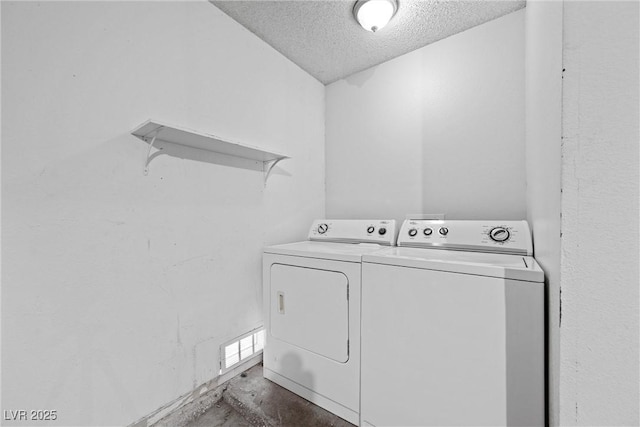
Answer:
[{"left": 263, "top": 220, "right": 396, "bottom": 424}]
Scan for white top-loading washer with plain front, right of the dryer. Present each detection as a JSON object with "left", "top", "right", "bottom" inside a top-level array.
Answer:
[{"left": 361, "top": 220, "right": 545, "bottom": 426}]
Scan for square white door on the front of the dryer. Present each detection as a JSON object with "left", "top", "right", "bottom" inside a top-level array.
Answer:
[{"left": 269, "top": 264, "right": 349, "bottom": 363}]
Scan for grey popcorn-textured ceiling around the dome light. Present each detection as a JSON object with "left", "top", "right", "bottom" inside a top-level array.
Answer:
[{"left": 211, "top": 0, "right": 525, "bottom": 84}]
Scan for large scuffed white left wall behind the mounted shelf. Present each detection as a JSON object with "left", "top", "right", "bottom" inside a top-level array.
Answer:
[{"left": 2, "top": 1, "right": 324, "bottom": 425}]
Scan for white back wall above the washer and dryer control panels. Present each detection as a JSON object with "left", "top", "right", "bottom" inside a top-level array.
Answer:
[{"left": 326, "top": 10, "right": 526, "bottom": 224}]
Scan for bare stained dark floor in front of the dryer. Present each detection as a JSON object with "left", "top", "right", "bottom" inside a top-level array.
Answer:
[{"left": 155, "top": 364, "right": 353, "bottom": 427}]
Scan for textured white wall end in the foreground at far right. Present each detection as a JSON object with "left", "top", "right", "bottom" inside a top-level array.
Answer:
[{"left": 559, "top": 1, "right": 640, "bottom": 426}]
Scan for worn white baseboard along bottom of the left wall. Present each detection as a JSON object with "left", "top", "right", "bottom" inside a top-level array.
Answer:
[{"left": 129, "top": 353, "right": 262, "bottom": 427}]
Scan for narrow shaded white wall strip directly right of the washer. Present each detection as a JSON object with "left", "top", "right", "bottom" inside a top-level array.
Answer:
[{"left": 525, "top": 0, "right": 562, "bottom": 425}]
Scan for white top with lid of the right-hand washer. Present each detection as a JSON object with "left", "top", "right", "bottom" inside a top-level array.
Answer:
[{"left": 362, "top": 247, "right": 544, "bottom": 282}]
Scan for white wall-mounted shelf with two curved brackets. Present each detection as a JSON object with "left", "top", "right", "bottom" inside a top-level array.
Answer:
[{"left": 131, "top": 120, "right": 290, "bottom": 184}]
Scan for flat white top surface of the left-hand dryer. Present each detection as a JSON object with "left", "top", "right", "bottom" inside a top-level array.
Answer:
[{"left": 264, "top": 241, "right": 383, "bottom": 262}]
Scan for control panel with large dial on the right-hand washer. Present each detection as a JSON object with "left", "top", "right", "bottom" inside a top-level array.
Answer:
[{"left": 398, "top": 219, "right": 533, "bottom": 256}]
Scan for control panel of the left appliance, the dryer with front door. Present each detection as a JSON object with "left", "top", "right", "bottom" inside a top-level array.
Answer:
[{"left": 309, "top": 219, "right": 397, "bottom": 246}]
